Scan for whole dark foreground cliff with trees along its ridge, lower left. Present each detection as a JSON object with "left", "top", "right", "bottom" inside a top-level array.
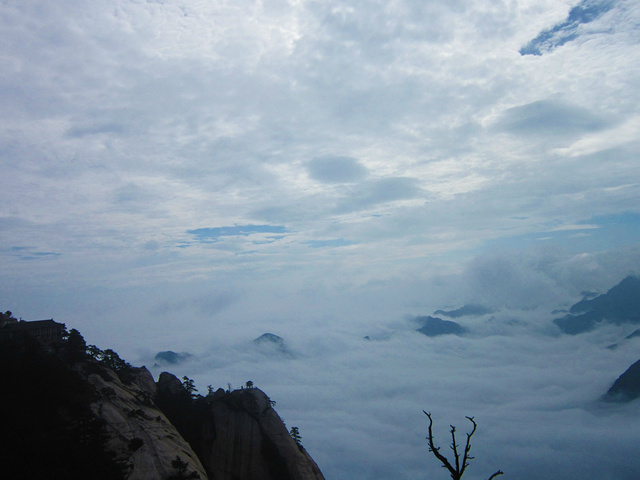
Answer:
[{"left": 0, "top": 330, "right": 324, "bottom": 480}]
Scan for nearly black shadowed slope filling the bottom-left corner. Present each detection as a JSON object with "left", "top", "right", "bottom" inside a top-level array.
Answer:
[{"left": 0, "top": 337, "right": 126, "bottom": 480}]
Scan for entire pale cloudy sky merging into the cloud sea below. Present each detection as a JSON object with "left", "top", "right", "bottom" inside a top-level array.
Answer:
[{"left": 0, "top": 0, "right": 640, "bottom": 480}]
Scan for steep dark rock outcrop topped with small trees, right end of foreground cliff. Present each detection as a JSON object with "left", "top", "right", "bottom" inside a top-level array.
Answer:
[{"left": 156, "top": 374, "right": 324, "bottom": 480}]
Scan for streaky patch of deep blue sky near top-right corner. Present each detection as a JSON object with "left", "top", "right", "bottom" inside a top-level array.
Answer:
[{"left": 520, "top": 0, "right": 616, "bottom": 55}]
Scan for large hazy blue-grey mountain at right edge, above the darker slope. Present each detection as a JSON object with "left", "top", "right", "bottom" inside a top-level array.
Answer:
[{"left": 553, "top": 276, "right": 640, "bottom": 335}]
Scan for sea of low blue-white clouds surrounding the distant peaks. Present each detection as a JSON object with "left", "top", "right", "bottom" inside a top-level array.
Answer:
[{"left": 127, "top": 251, "right": 640, "bottom": 480}]
